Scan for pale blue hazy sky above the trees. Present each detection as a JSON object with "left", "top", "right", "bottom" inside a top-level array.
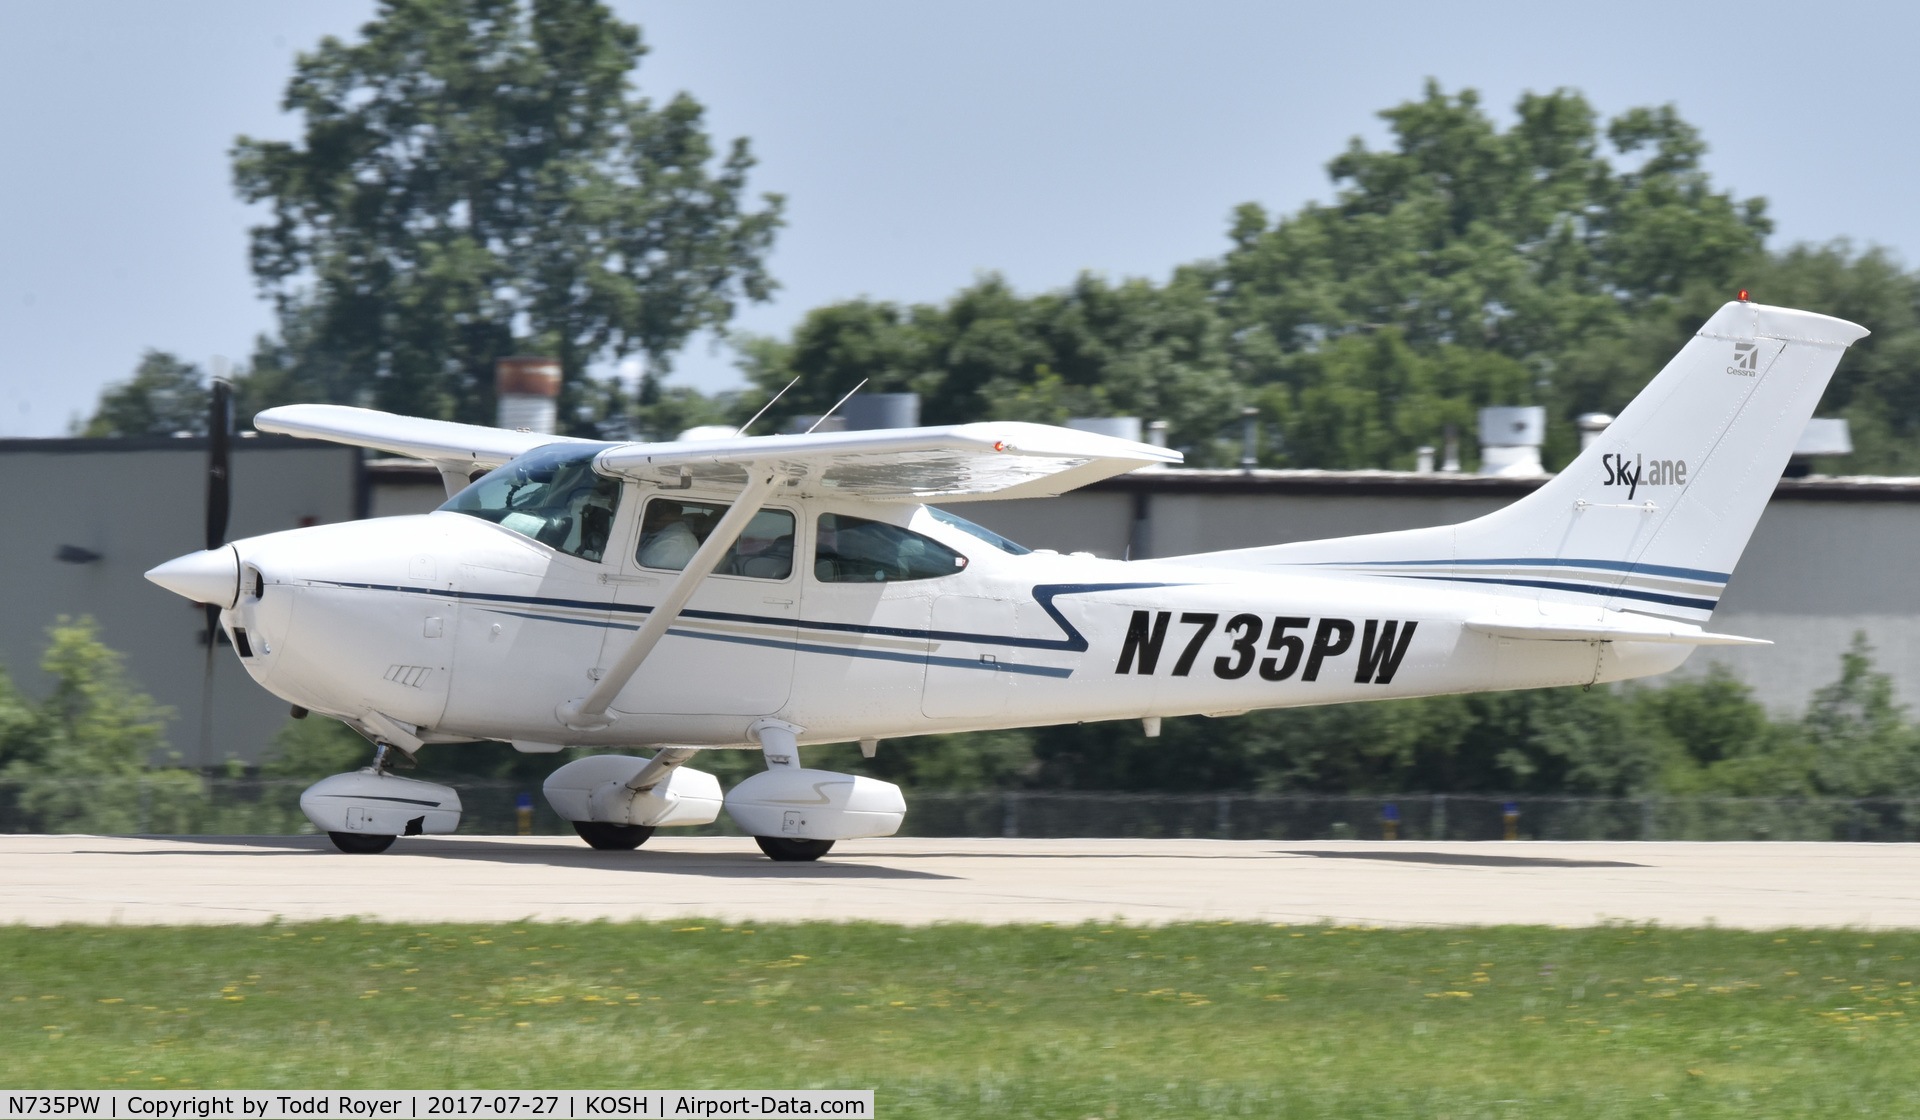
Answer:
[{"left": 0, "top": 0, "right": 1920, "bottom": 438}]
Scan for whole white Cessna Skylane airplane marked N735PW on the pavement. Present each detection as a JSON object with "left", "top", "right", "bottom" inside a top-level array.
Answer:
[{"left": 148, "top": 294, "right": 1866, "bottom": 861}]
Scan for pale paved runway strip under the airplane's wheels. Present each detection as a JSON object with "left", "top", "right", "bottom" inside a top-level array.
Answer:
[{"left": 0, "top": 836, "right": 1920, "bottom": 928}]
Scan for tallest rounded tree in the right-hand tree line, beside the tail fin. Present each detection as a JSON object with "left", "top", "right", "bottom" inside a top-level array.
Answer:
[{"left": 1202, "top": 81, "right": 1770, "bottom": 467}]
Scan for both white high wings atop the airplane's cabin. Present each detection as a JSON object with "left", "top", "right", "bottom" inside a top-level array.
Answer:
[{"left": 253, "top": 405, "right": 1181, "bottom": 501}]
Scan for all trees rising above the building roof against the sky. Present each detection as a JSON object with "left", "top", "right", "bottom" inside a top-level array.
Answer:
[{"left": 86, "top": 62, "right": 1920, "bottom": 475}]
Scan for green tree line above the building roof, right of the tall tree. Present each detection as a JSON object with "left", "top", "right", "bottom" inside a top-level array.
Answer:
[{"left": 737, "top": 83, "right": 1920, "bottom": 473}]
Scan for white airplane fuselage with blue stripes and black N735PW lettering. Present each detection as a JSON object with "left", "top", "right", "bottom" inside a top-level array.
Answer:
[{"left": 223, "top": 482, "right": 1688, "bottom": 749}]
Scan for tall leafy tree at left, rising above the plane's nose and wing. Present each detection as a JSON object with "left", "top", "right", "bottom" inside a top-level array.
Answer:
[{"left": 234, "top": 0, "right": 781, "bottom": 421}]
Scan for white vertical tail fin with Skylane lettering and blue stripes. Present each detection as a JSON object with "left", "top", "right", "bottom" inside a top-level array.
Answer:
[{"left": 1183, "top": 302, "right": 1866, "bottom": 621}]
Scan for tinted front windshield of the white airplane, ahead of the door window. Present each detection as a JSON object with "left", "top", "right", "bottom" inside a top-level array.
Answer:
[{"left": 442, "top": 444, "right": 620, "bottom": 563}]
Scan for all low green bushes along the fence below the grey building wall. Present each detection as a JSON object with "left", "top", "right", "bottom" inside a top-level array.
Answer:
[{"left": 0, "top": 619, "right": 1920, "bottom": 832}]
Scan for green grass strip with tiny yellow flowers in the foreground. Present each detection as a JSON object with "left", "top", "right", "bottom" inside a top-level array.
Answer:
[{"left": 0, "top": 922, "right": 1920, "bottom": 1120}]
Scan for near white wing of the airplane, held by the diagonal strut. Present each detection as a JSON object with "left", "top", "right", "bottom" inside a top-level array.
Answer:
[{"left": 599, "top": 421, "right": 1181, "bottom": 501}]
